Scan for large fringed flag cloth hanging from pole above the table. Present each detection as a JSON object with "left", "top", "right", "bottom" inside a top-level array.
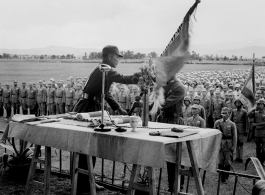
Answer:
[{"left": 149, "top": 0, "right": 200, "bottom": 115}]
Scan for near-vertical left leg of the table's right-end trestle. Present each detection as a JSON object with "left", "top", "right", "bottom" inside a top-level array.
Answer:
[{"left": 173, "top": 142, "right": 182, "bottom": 195}]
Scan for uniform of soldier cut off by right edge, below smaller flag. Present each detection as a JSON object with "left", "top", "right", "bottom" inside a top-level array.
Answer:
[{"left": 248, "top": 99, "right": 265, "bottom": 164}]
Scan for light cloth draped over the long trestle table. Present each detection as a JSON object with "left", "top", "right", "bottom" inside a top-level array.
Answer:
[{"left": 4, "top": 119, "right": 222, "bottom": 194}]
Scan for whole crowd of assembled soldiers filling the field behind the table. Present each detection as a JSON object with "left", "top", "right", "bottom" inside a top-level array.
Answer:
[{"left": 0, "top": 64, "right": 265, "bottom": 187}]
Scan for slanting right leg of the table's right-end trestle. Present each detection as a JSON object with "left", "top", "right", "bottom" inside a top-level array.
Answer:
[{"left": 186, "top": 141, "right": 204, "bottom": 195}]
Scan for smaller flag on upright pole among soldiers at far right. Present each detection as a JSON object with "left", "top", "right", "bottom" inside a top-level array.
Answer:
[{"left": 241, "top": 64, "right": 256, "bottom": 110}]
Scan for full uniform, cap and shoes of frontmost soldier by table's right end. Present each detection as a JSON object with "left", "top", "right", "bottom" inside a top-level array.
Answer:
[{"left": 214, "top": 107, "right": 237, "bottom": 182}]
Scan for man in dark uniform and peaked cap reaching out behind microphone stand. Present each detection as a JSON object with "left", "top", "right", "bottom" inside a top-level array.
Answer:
[{"left": 73, "top": 45, "right": 139, "bottom": 194}]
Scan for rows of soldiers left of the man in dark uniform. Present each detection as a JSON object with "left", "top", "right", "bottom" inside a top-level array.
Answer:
[{"left": 0, "top": 80, "right": 83, "bottom": 119}]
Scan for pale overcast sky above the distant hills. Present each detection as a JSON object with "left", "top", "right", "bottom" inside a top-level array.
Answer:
[{"left": 0, "top": 0, "right": 265, "bottom": 49}]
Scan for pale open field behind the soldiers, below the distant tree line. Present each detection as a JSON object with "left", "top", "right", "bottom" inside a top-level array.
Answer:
[{"left": 0, "top": 61, "right": 253, "bottom": 85}]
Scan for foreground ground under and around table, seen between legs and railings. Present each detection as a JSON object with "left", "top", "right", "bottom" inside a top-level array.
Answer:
[{"left": 0, "top": 118, "right": 257, "bottom": 195}]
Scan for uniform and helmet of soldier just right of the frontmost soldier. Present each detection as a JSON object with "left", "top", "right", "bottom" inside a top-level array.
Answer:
[{"left": 230, "top": 98, "right": 249, "bottom": 162}]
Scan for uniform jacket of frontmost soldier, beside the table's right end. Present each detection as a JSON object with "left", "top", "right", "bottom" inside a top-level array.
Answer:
[{"left": 214, "top": 118, "right": 237, "bottom": 152}]
